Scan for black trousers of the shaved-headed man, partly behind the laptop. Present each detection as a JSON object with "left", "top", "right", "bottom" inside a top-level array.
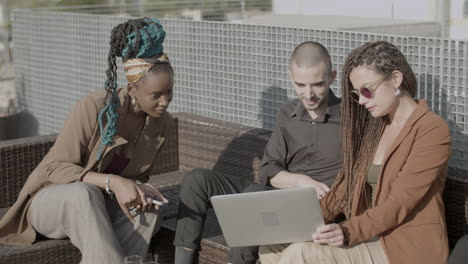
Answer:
[{"left": 174, "top": 169, "right": 272, "bottom": 264}]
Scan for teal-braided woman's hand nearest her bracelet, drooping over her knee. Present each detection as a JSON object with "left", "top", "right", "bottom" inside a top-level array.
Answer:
[{"left": 110, "top": 175, "right": 144, "bottom": 223}]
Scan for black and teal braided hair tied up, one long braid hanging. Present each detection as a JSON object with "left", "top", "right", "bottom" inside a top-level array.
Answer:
[{"left": 97, "top": 17, "right": 166, "bottom": 160}]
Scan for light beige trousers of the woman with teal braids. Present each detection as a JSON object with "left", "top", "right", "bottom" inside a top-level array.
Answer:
[{"left": 29, "top": 182, "right": 159, "bottom": 264}]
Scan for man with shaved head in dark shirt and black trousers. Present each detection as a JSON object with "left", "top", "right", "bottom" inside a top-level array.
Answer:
[{"left": 174, "top": 42, "right": 341, "bottom": 264}]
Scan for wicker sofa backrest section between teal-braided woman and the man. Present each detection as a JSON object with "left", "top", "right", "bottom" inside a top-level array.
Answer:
[{"left": 174, "top": 113, "right": 270, "bottom": 182}]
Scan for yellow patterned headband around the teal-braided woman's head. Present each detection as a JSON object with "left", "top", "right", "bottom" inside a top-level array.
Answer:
[{"left": 124, "top": 53, "right": 169, "bottom": 83}]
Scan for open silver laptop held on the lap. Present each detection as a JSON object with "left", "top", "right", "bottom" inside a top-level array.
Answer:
[{"left": 211, "top": 187, "right": 324, "bottom": 247}]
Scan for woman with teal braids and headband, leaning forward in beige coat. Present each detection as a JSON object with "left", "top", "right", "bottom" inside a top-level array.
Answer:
[{"left": 0, "top": 18, "right": 174, "bottom": 263}]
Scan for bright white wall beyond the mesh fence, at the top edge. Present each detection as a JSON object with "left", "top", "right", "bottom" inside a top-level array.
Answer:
[{"left": 273, "top": 0, "right": 438, "bottom": 21}]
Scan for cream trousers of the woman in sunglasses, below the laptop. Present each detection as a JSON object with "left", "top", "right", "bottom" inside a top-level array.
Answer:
[{"left": 259, "top": 240, "right": 388, "bottom": 264}]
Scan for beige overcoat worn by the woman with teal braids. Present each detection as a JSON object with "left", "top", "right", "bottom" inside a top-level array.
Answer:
[{"left": 0, "top": 89, "right": 173, "bottom": 244}]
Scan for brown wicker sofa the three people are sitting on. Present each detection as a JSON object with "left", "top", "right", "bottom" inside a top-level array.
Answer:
[{"left": 0, "top": 113, "right": 468, "bottom": 264}]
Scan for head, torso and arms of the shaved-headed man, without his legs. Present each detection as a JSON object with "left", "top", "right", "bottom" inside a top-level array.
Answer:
[{"left": 261, "top": 41, "right": 341, "bottom": 194}]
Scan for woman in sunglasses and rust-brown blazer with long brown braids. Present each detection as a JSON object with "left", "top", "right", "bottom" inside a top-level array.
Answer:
[{"left": 260, "top": 41, "right": 450, "bottom": 264}]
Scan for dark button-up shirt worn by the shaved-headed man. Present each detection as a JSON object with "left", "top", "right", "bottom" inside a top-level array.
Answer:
[{"left": 261, "top": 91, "right": 341, "bottom": 186}]
